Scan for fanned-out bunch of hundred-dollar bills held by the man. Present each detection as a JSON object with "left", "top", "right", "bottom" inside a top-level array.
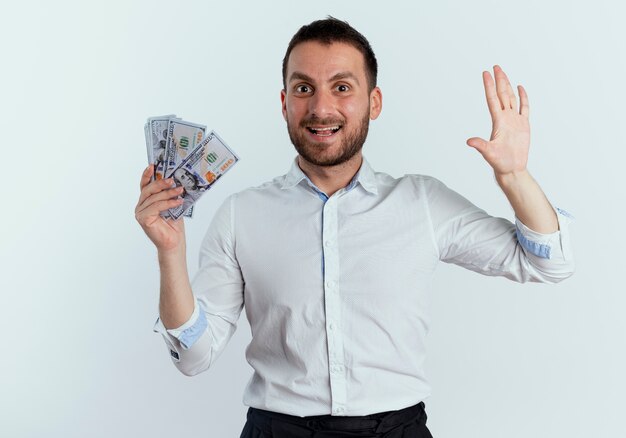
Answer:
[{"left": 144, "top": 114, "right": 239, "bottom": 219}]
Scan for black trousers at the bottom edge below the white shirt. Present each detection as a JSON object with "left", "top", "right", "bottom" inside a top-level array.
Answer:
[{"left": 240, "top": 402, "right": 432, "bottom": 438}]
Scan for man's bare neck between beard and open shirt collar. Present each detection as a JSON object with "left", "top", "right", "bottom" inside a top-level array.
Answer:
[{"left": 298, "top": 152, "right": 363, "bottom": 197}]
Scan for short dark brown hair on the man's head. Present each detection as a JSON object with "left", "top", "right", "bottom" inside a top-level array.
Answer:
[{"left": 283, "top": 15, "right": 378, "bottom": 91}]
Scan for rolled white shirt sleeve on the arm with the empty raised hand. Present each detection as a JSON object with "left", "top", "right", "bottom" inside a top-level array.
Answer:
[{"left": 424, "top": 179, "right": 574, "bottom": 283}]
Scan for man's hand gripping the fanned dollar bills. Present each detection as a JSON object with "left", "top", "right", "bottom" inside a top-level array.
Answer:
[{"left": 135, "top": 164, "right": 185, "bottom": 252}]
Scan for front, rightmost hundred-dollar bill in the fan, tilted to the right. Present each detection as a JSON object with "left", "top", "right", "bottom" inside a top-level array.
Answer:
[{"left": 169, "top": 131, "right": 239, "bottom": 219}]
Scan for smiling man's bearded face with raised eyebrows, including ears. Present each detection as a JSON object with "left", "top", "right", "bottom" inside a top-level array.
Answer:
[{"left": 281, "top": 41, "right": 382, "bottom": 166}]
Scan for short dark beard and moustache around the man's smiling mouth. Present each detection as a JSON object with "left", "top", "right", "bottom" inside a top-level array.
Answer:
[{"left": 287, "top": 111, "right": 370, "bottom": 167}]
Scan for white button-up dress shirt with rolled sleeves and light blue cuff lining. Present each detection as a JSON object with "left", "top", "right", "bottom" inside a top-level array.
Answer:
[{"left": 155, "top": 159, "right": 573, "bottom": 416}]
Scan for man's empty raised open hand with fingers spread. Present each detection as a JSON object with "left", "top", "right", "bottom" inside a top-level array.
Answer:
[{"left": 467, "top": 65, "right": 530, "bottom": 177}]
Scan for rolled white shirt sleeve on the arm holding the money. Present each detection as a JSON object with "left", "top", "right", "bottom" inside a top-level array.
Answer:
[{"left": 154, "top": 196, "right": 244, "bottom": 376}]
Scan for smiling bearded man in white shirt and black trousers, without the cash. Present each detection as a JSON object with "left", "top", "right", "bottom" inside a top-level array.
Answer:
[{"left": 136, "top": 17, "right": 573, "bottom": 438}]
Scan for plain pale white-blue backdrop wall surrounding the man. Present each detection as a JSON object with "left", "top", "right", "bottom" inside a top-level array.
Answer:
[{"left": 0, "top": 0, "right": 626, "bottom": 438}]
